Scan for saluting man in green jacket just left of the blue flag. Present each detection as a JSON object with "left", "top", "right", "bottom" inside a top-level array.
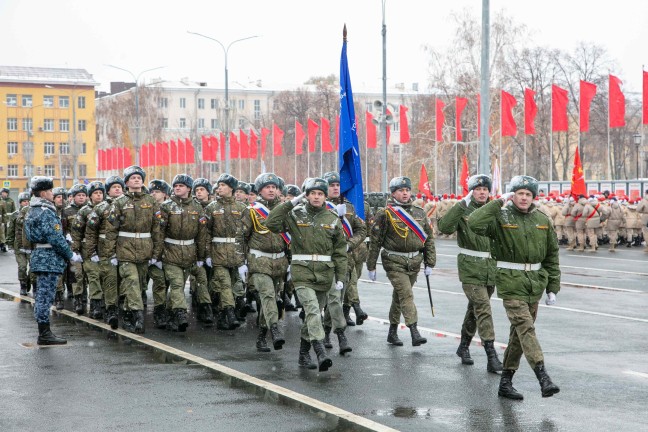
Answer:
[{"left": 266, "top": 178, "right": 347, "bottom": 372}]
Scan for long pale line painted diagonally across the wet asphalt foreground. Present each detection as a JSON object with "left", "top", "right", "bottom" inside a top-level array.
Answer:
[{"left": 0, "top": 288, "right": 397, "bottom": 432}]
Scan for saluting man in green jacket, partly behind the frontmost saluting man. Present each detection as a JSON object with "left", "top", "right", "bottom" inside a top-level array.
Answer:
[{"left": 438, "top": 174, "right": 502, "bottom": 372}]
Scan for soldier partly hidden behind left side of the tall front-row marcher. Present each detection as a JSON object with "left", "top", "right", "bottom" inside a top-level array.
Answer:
[{"left": 84, "top": 176, "right": 126, "bottom": 330}]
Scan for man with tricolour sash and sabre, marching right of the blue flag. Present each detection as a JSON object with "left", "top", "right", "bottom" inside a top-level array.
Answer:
[{"left": 367, "top": 177, "right": 436, "bottom": 346}]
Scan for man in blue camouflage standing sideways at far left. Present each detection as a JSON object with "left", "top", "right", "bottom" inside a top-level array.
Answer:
[{"left": 25, "top": 177, "right": 72, "bottom": 345}]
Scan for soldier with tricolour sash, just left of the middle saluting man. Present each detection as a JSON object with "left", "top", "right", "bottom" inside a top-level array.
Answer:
[{"left": 243, "top": 173, "right": 288, "bottom": 352}]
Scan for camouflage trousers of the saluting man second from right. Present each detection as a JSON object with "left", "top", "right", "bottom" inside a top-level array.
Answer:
[{"left": 461, "top": 284, "right": 495, "bottom": 341}]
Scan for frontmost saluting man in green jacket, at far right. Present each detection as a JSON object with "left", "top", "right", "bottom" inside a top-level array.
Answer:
[{"left": 468, "top": 176, "right": 560, "bottom": 399}]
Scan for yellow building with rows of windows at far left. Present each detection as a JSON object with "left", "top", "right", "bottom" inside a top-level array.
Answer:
[{"left": 0, "top": 66, "right": 99, "bottom": 194}]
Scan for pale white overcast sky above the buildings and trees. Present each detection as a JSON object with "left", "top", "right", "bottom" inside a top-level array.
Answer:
[{"left": 0, "top": 0, "right": 648, "bottom": 92}]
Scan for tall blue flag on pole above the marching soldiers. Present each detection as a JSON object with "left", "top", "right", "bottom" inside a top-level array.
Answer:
[{"left": 339, "top": 32, "right": 365, "bottom": 220}]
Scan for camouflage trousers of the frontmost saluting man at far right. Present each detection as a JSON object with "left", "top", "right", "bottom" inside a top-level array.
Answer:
[{"left": 504, "top": 300, "right": 544, "bottom": 370}]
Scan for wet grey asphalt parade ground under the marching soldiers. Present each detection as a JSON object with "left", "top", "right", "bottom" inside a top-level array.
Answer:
[{"left": 0, "top": 239, "right": 648, "bottom": 432}]
